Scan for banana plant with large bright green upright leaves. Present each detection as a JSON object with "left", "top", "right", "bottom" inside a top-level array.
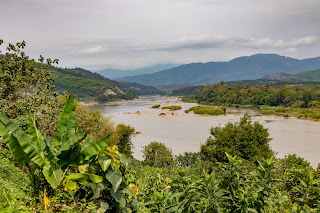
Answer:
[{"left": 0, "top": 95, "right": 111, "bottom": 191}]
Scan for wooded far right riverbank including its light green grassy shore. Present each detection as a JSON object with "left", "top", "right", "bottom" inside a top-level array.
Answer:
[{"left": 179, "top": 83, "right": 320, "bottom": 119}]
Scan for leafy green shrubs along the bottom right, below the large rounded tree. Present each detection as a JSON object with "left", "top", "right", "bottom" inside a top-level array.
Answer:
[{"left": 130, "top": 154, "right": 320, "bottom": 212}]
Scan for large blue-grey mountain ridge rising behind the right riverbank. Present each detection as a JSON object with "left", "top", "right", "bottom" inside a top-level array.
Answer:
[{"left": 117, "top": 54, "right": 320, "bottom": 86}]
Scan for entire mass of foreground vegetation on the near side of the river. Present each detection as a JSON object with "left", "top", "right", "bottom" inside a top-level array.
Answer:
[{"left": 0, "top": 40, "right": 320, "bottom": 213}]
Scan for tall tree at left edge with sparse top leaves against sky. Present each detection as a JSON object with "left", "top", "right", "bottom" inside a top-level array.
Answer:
[{"left": 0, "top": 40, "right": 58, "bottom": 118}]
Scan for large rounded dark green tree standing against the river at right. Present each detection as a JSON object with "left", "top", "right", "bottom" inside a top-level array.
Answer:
[{"left": 200, "top": 114, "right": 273, "bottom": 163}]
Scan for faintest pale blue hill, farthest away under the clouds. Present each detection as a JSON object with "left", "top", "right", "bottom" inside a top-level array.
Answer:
[{"left": 96, "top": 64, "right": 180, "bottom": 79}]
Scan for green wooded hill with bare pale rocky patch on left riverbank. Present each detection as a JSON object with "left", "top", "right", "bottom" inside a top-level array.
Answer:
[{"left": 51, "top": 67, "right": 161, "bottom": 102}]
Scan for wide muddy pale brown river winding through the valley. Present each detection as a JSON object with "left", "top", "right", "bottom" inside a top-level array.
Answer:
[{"left": 91, "top": 96, "right": 320, "bottom": 168}]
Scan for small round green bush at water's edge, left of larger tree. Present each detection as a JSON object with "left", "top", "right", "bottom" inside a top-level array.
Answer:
[{"left": 142, "top": 142, "right": 173, "bottom": 167}]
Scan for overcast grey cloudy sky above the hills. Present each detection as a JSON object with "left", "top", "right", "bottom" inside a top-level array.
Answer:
[{"left": 0, "top": 0, "right": 320, "bottom": 71}]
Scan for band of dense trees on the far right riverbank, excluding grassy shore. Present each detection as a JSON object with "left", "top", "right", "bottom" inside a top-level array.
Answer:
[{"left": 193, "top": 83, "right": 320, "bottom": 108}]
